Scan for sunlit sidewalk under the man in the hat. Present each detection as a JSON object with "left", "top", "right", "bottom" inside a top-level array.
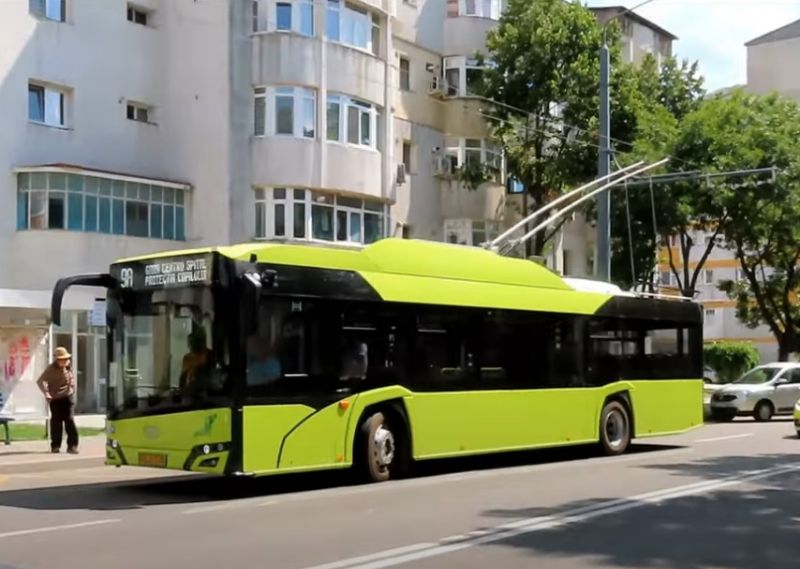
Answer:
[{"left": 0, "top": 435, "right": 106, "bottom": 474}]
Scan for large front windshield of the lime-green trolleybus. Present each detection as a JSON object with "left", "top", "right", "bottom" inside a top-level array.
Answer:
[{"left": 108, "top": 287, "right": 229, "bottom": 413}]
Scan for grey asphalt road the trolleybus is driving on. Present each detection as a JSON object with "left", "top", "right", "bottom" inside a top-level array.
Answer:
[{"left": 0, "top": 420, "right": 800, "bottom": 569}]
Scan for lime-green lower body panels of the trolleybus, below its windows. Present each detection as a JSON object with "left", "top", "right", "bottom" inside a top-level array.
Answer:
[{"left": 108, "top": 380, "right": 703, "bottom": 476}]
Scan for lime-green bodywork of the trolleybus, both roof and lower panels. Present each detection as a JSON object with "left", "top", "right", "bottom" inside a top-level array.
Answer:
[{"left": 107, "top": 239, "right": 703, "bottom": 476}]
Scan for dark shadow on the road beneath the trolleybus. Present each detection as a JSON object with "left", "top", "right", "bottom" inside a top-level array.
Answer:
[{"left": 0, "top": 444, "right": 680, "bottom": 511}]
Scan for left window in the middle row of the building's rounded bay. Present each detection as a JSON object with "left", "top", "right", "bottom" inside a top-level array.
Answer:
[{"left": 254, "top": 87, "right": 317, "bottom": 138}]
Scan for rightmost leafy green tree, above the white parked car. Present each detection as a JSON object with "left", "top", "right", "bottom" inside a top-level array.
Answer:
[{"left": 682, "top": 91, "right": 800, "bottom": 360}]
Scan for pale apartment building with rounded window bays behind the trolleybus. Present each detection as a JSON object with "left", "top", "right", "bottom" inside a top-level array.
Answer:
[{"left": 0, "top": 0, "right": 673, "bottom": 416}]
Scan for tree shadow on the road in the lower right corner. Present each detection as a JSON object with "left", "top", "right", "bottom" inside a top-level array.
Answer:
[{"left": 482, "top": 455, "right": 800, "bottom": 569}]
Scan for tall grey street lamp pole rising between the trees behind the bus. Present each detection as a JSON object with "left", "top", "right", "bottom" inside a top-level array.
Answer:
[{"left": 595, "top": 0, "right": 654, "bottom": 281}]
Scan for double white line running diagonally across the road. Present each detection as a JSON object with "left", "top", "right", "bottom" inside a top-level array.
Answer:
[{"left": 306, "top": 465, "right": 800, "bottom": 569}]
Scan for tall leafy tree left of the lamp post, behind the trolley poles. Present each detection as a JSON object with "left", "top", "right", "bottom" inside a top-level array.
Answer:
[{"left": 478, "top": 0, "right": 631, "bottom": 255}]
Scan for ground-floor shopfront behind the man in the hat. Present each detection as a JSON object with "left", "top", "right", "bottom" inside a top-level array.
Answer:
[{"left": 0, "top": 289, "right": 107, "bottom": 419}]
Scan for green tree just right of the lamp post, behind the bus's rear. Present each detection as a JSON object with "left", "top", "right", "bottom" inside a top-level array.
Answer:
[{"left": 612, "top": 55, "right": 713, "bottom": 288}]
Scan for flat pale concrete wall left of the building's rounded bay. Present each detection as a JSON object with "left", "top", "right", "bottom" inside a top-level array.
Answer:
[{"left": 0, "top": 0, "right": 230, "bottom": 289}]
